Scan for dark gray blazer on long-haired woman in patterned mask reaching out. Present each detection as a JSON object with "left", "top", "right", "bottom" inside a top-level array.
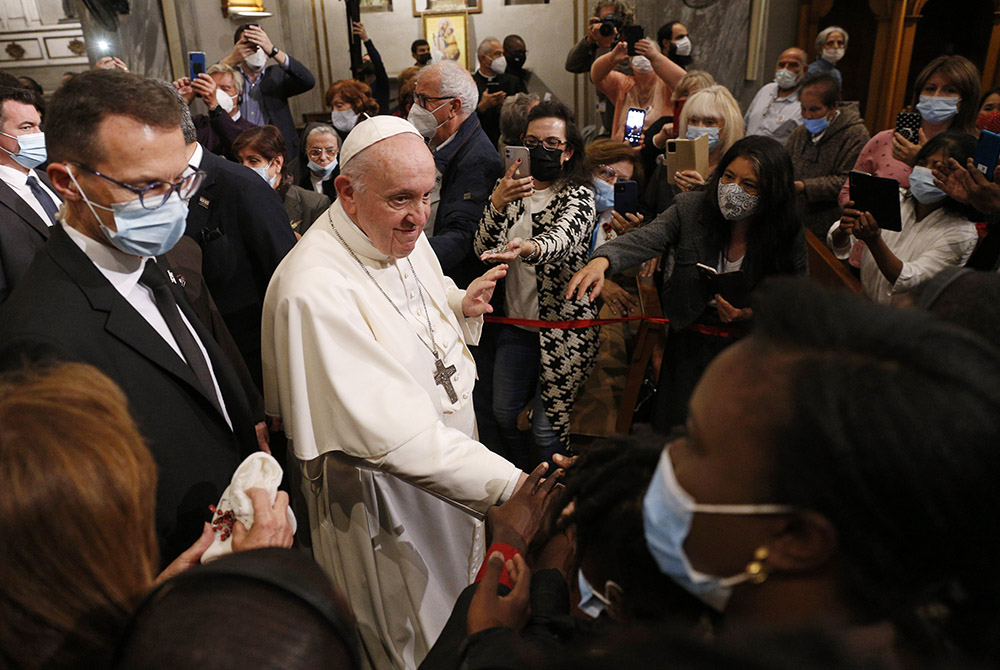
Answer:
[{"left": 594, "top": 191, "right": 808, "bottom": 330}]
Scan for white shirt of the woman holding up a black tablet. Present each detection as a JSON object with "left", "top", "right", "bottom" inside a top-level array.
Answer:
[{"left": 826, "top": 189, "right": 979, "bottom": 305}]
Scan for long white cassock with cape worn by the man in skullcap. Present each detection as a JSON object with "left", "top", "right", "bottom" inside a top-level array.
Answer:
[{"left": 262, "top": 201, "right": 520, "bottom": 670}]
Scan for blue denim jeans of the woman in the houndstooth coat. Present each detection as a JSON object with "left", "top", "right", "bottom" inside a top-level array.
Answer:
[{"left": 493, "top": 325, "right": 562, "bottom": 472}]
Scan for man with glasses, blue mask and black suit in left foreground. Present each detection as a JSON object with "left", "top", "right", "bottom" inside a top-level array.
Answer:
[{"left": 0, "top": 70, "right": 256, "bottom": 563}]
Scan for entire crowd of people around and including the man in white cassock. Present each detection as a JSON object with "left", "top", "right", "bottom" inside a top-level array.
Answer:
[{"left": 0, "top": 5, "right": 1000, "bottom": 670}]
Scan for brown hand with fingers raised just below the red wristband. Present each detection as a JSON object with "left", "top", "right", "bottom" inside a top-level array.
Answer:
[{"left": 465, "top": 551, "right": 531, "bottom": 635}]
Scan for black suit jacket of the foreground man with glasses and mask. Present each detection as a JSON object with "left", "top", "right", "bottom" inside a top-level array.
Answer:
[{"left": 0, "top": 226, "right": 256, "bottom": 564}]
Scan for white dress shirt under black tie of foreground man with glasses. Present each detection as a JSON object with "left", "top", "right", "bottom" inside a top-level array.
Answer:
[{"left": 62, "top": 224, "right": 233, "bottom": 428}]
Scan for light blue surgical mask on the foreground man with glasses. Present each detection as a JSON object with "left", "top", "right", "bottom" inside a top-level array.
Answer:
[{"left": 66, "top": 165, "right": 188, "bottom": 256}]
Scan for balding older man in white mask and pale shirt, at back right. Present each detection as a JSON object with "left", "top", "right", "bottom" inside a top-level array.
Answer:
[{"left": 743, "top": 47, "right": 806, "bottom": 144}]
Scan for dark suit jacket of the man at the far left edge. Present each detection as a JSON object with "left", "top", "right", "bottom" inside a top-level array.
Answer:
[{"left": 0, "top": 170, "right": 58, "bottom": 303}]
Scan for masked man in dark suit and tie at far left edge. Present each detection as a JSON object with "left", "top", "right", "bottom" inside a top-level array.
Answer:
[{"left": 0, "top": 86, "right": 60, "bottom": 303}]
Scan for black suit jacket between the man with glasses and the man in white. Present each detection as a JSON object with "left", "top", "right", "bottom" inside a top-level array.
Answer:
[{"left": 185, "top": 151, "right": 295, "bottom": 388}]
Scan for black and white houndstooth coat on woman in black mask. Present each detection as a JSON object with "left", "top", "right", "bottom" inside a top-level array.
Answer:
[{"left": 475, "top": 182, "right": 600, "bottom": 448}]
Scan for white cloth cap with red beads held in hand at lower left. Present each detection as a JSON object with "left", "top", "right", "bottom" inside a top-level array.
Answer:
[{"left": 201, "top": 451, "right": 298, "bottom": 563}]
